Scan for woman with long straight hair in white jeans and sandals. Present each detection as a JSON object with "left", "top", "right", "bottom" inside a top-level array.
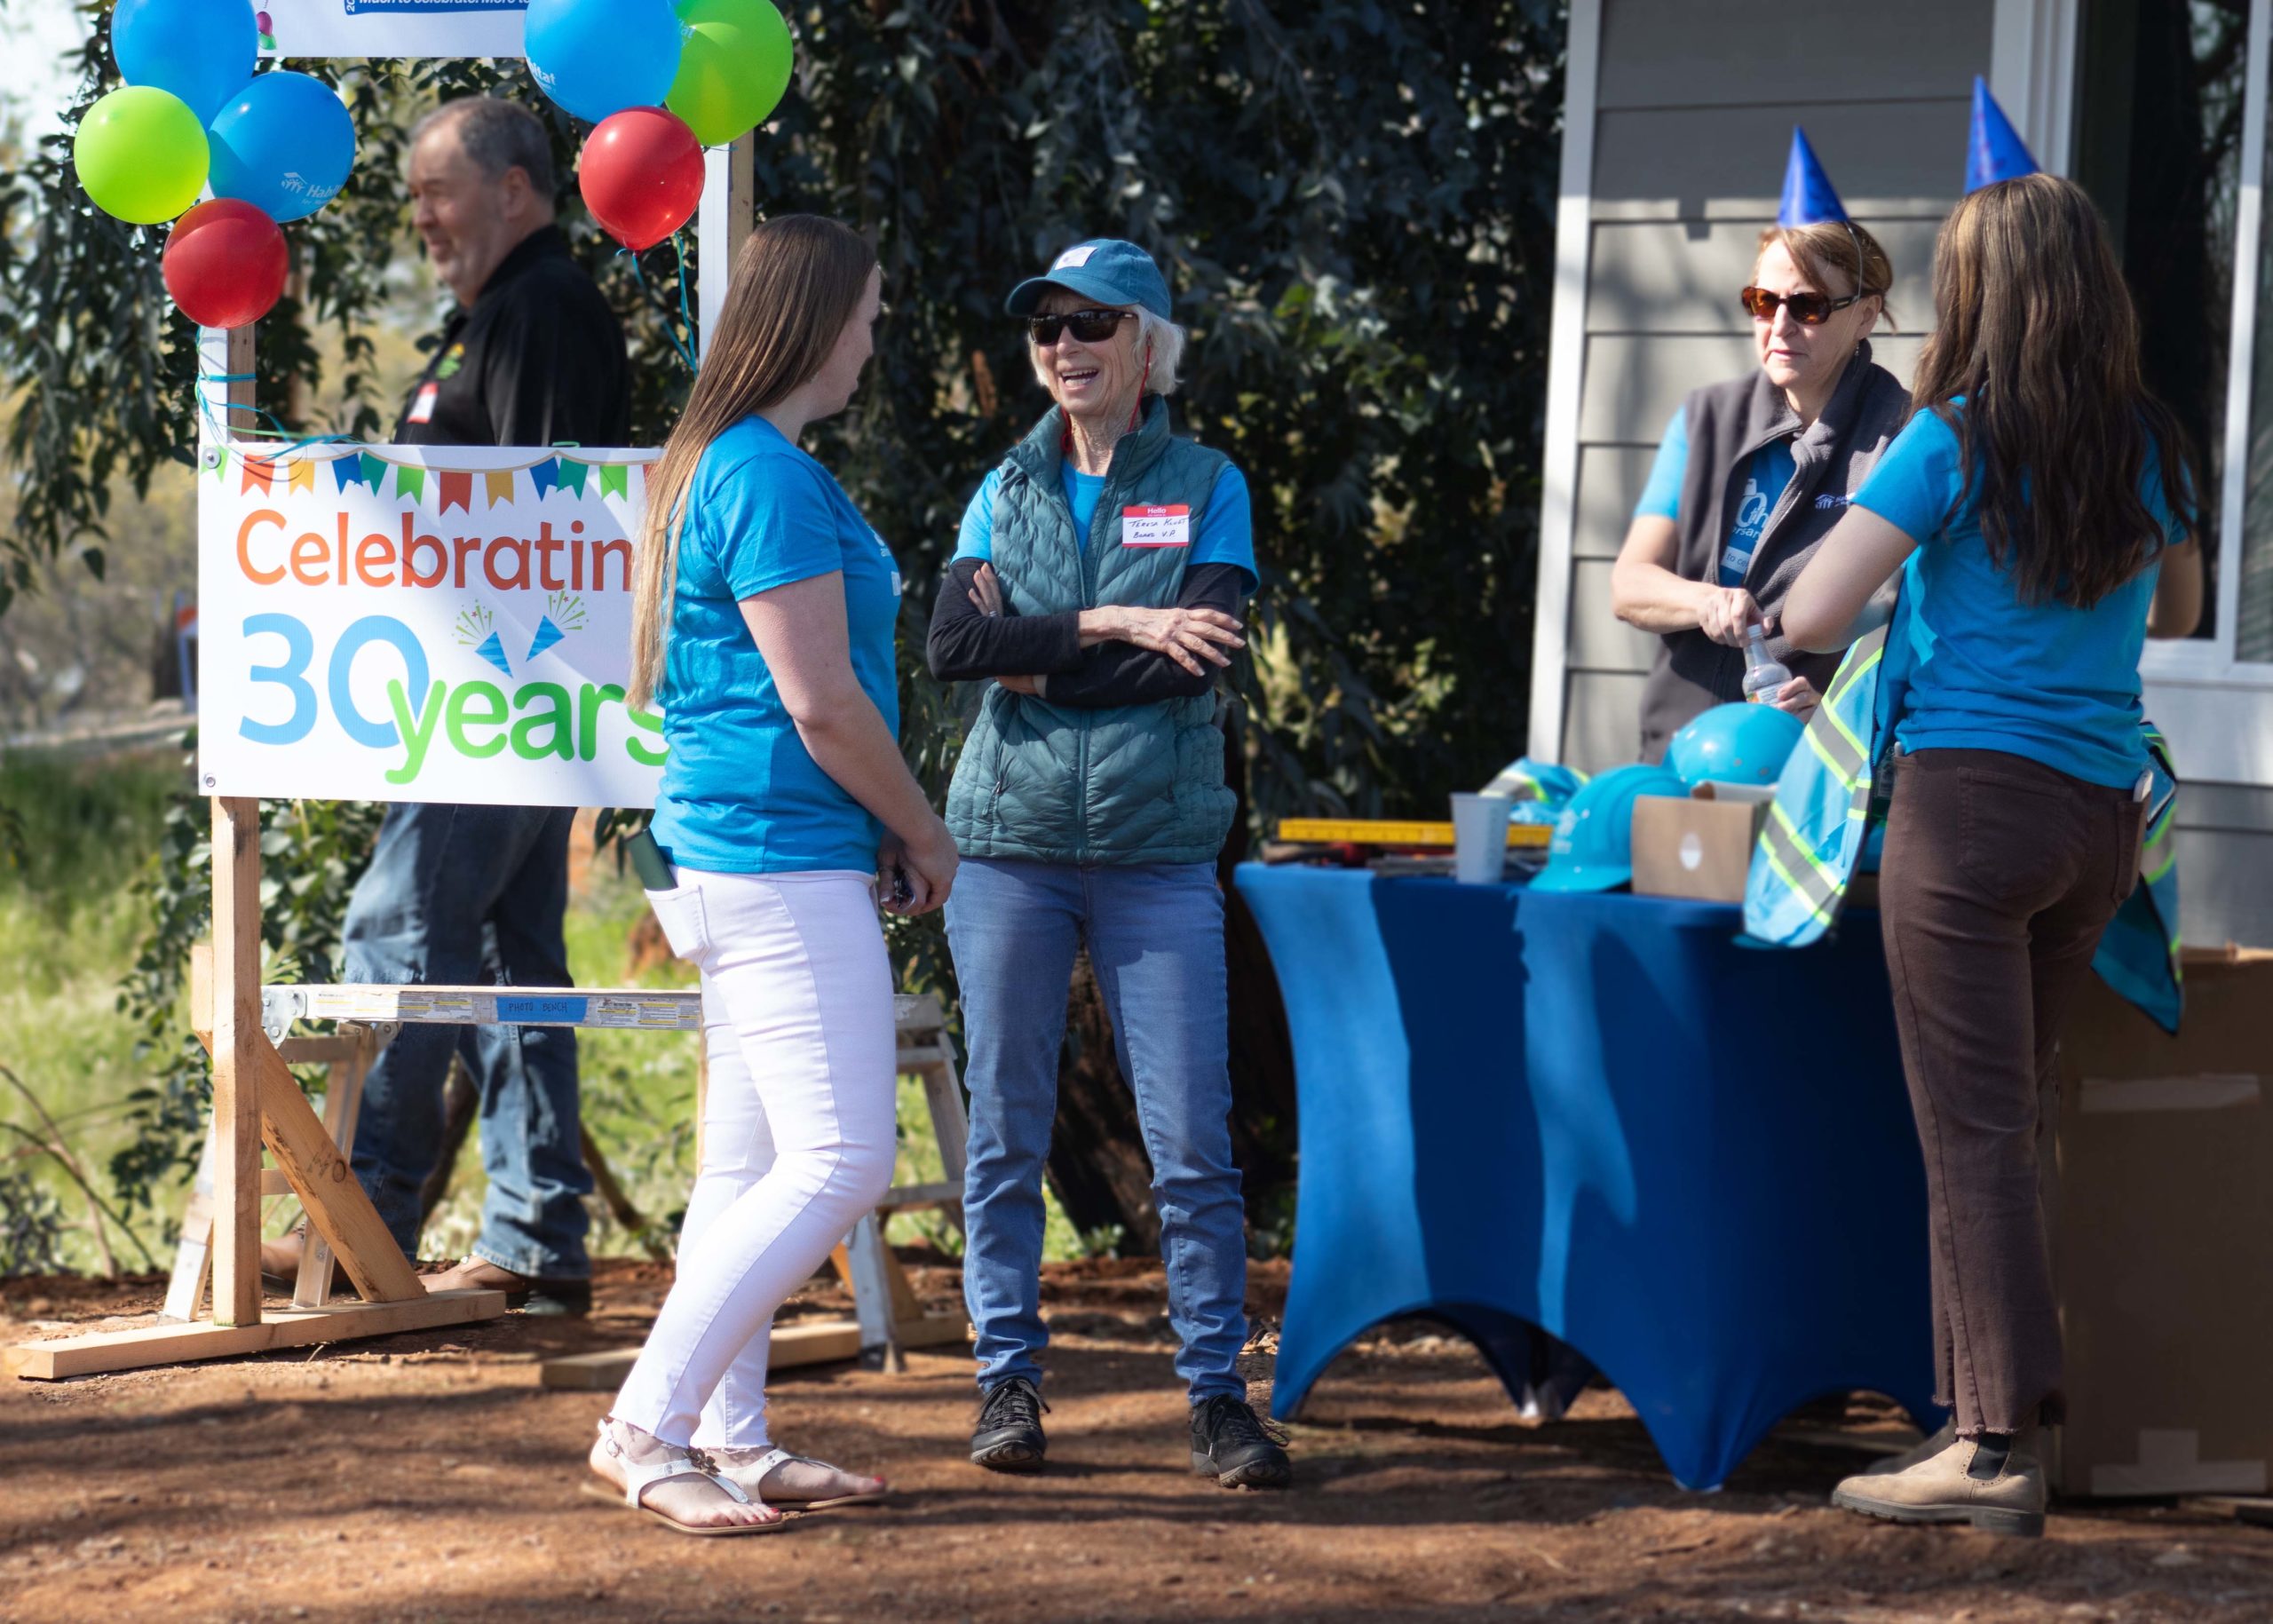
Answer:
[{"left": 591, "top": 216, "right": 957, "bottom": 1533}]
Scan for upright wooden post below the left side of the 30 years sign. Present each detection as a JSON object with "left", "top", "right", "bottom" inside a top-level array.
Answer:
[{"left": 211, "top": 791, "right": 261, "bottom": 1326}]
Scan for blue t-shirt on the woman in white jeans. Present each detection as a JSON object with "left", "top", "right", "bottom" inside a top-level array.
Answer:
[{"left": 654, "top": 416, "right": 900, "bottom": 874}]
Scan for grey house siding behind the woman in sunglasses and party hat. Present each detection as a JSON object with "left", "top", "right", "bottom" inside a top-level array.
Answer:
[{"left": 1562, "top": 0, "right": 1993, "bottom": 771}]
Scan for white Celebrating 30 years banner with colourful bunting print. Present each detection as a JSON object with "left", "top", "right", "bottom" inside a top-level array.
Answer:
[{"left": 198, "top": 446, "right": 664, "bottom": 807}]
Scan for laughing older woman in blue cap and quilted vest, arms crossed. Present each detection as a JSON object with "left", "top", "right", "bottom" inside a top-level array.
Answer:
[{"left": 930, "top": 242, "right": 1289, "bottom": 1487}]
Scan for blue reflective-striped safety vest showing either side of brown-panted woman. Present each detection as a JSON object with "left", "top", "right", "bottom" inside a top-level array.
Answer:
[{"left": 1744, "top": 600, "right": 2184, "bottom": 1033}]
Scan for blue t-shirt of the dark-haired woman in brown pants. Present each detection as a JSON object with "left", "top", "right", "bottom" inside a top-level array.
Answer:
[{"left": 1855, "top": 412, "right": 2173, "bottom": 787}]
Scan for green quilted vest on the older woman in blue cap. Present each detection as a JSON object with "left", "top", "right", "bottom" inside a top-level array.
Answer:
[{"left": 948, "top": 396, "right": 1234, "bottom": 862}]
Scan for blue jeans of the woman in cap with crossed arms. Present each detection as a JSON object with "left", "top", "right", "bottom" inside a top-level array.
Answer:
[{"left": 948, "top": 858, "right": 1247, "bottom": 1404}]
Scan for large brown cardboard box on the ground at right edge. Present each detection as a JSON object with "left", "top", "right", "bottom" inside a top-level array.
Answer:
[{"left": 2046, "top": 953, "right": 2273, "bottom": 1497}]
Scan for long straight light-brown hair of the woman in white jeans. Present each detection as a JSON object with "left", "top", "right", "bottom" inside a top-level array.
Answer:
[{"left": 625, "top": 214, "right": 875, "bottom": 709}]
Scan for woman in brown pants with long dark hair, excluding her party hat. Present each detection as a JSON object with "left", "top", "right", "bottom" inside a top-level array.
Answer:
[{"left": 1785, "top": 175, "right": 2203, "bottom": 1533}]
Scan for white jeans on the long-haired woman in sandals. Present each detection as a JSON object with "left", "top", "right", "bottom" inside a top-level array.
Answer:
[{"left": 614, "top": 869, "right": 898, "bottom": 1449}]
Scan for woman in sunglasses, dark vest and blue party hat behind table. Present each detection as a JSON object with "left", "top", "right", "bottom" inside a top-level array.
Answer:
[{"left": 1609, "top": 130, "right": 1909, "bottom": 762}]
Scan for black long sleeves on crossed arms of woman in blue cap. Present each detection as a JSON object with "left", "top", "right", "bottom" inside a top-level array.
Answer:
[{"left": 925, "top": 558, "right": 1247, "bottom": 709}]
